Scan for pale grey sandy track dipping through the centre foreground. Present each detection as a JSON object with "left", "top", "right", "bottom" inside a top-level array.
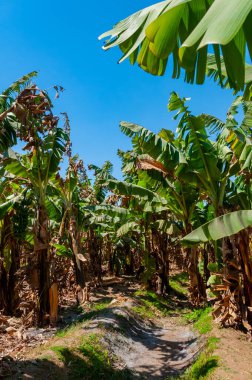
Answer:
[{"left": 84, "top": 299, "right": 202, "bottom": 379}]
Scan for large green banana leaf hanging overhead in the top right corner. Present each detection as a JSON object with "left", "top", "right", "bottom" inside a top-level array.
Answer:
[{"left": 99, "top": 0, "right": 252, "bottom": 90}]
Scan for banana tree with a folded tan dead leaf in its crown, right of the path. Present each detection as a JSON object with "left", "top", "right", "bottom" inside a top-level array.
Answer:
[{"left": 118, "top": 122, "right": 209, "bottom": 304}]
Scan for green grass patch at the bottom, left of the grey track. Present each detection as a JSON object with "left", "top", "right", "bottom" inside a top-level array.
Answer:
[{"left": 51, "top": 334, "right": 132, "bottom": 380}]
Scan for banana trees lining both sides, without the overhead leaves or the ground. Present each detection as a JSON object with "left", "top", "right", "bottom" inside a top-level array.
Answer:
[{"left": 0, "top": 73, "right": 252, "bottom": 332}]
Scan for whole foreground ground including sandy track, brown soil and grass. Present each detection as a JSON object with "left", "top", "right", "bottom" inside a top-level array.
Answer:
[{"left": 0, "top": 276, "right": 252, "bottom": 380}]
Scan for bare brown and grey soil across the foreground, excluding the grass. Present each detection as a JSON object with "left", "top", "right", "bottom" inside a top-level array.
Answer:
[{"left": 0, "top": 282, "right": 252, "bottom": 380}]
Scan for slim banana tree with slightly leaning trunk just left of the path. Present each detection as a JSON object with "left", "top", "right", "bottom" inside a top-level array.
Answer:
[{"left": 46, "top": 151, "right": 92, "bottom": 304}]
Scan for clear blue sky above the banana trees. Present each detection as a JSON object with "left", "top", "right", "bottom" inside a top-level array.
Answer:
[{"left": 0, "top": 0, "right": 233, "bottom": 176}]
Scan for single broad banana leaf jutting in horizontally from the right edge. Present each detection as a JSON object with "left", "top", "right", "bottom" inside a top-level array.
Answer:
[{"left": 182, "top": 210, "right": 252, "bottom": 245}]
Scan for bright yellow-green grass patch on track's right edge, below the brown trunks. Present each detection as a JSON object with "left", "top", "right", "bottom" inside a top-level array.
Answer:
[{"left": 184, "top": 307, "right": 213, "bottom": 334}]
